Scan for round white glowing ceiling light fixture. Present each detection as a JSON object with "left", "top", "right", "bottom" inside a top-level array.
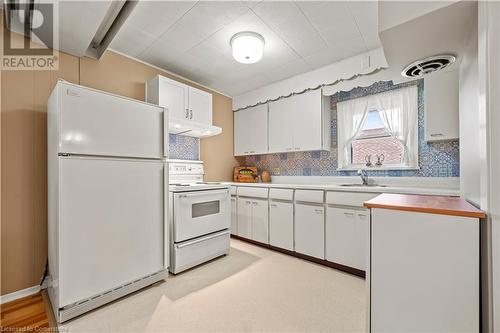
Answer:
[{"left": 229, "top": 31, "right": 265, "bottom": 64}]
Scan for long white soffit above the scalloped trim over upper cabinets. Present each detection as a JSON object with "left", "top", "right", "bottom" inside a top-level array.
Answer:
[{"left": 233, "top": 49, "right": 387, "bottom": 110}]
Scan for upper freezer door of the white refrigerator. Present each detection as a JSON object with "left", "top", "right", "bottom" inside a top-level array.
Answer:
[{"left": 58, "top": 83, "right": 167, "bottom": 158}]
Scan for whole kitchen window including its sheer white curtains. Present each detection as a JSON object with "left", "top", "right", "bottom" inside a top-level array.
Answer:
[{"left": 337, "top": 86, "right": 418, "bottom": 170}]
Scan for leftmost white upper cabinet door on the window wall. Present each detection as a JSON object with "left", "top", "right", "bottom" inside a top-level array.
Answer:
[{"left": 234, "top": 104, "right": 268, "bottom": 156}]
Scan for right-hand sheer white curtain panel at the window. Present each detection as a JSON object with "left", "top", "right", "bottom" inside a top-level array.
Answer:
[{"left": 373, "top": 86, "right": 418, "bottom": 167}]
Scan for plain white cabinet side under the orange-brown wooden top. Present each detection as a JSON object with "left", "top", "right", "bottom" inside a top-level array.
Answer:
[{"left": 369, "top": 208, "right": 480, "bottom": 332}]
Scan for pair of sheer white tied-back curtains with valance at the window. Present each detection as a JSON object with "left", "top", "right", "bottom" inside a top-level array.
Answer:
[{"left": 337, "top": 86, "right": 418, "bottom": 169}]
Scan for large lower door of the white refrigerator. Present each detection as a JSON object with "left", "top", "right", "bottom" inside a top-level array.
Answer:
[{"left": 59, "top": 157, "right": 164, "bottom": 307}]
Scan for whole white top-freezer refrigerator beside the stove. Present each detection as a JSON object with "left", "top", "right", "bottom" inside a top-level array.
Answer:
[{"left": 47, "top": 81, "right": 169, "bottom": 322}]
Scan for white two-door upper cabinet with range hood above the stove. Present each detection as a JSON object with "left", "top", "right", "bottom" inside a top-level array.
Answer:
[{"left": 146, "top": 75, "right": 217, "bottom": 137}]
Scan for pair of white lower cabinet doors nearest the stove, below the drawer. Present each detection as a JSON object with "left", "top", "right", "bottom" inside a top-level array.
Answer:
[{"left": 237, "top": 197, "right": 269, "bottom": 244}]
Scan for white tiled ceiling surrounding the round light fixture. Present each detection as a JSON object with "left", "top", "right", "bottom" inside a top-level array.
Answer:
[{"left": 112, "top": 1, "right": 380, "bottom": 95}]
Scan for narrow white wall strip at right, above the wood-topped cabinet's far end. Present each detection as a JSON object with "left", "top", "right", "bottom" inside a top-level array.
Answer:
[{"left": 459, "top": 23, "right": 481, "bottom": 206}]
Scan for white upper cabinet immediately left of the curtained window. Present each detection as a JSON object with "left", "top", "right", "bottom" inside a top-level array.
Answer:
[{"left": 269, "top": 89, "right": 330, "bottom": 153}]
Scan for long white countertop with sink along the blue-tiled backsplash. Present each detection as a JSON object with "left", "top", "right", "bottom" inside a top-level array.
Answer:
[{"left": 226, "top": 177, "right": 460, "bottom": 196}]
